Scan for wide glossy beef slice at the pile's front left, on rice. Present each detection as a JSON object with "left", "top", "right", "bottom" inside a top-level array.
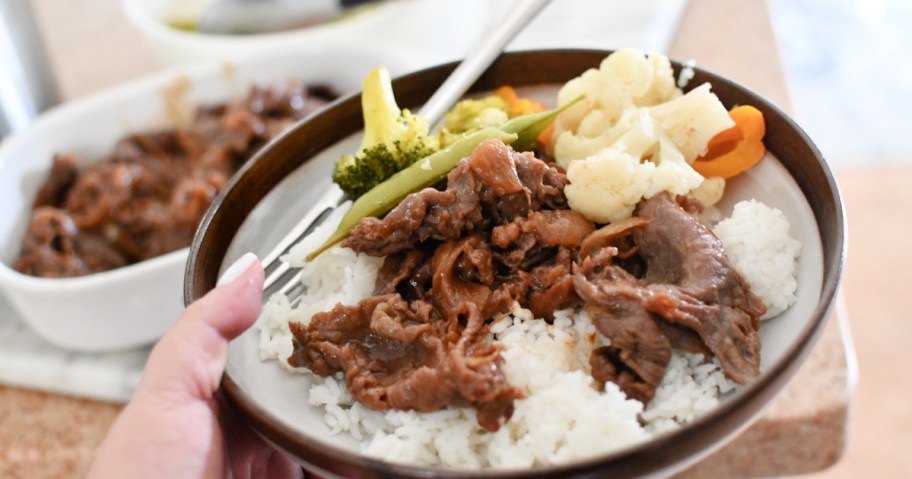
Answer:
[{"left": 288, "top": 294, "right": 522, "bottom": 431}]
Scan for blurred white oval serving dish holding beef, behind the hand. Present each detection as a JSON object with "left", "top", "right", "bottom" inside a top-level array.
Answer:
[{"left": 0, "top": 46, "right": 403, "bottom": 351}]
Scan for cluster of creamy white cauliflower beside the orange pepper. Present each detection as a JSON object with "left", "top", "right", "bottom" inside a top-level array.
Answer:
[{"left": 554, "top": 50, "right": 733, "bottom": 223}]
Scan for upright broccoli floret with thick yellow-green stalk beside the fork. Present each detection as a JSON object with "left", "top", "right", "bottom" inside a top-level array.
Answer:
[{"left": 332, "top": 67, "right": 440, "bottom": 199}]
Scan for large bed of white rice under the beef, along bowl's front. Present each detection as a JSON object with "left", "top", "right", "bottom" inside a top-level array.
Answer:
[{"left": 258, "top": 197, "right": 800, "bottom": 469}]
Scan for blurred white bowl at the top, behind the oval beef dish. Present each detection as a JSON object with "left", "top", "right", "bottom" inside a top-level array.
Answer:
[{"left": 123, "top": 0, "right": 491, "bottom": 69}]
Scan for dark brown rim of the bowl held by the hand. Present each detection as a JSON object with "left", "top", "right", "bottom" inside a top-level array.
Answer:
[{"left": 184, "top": 49, "right": 845, "bottom": 478}]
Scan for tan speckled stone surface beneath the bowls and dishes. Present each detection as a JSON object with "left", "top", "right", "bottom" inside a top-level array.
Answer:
[{"left": 0, "top": 0, "right": 854, "bottom": 478}]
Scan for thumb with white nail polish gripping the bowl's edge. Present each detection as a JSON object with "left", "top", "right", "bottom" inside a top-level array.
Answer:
[{"left": 136, "top": 253, "right": 263, "bottom": 400}]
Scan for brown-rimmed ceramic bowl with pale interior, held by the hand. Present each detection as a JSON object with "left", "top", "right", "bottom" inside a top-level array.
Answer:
[{"left": 184, "top": 50, "right": 845, "bottom": 478}]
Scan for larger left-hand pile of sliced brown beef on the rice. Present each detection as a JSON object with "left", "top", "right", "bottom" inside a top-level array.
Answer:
[{"left": 290, "top": 141, "right": 594, "bottom": 430}]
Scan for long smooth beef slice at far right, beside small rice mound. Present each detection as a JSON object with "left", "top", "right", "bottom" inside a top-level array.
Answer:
[{"left": 634, "top": 193, "right": 766, "bottom": 384}]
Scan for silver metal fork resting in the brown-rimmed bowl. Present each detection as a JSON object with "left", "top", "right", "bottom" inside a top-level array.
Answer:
[{"left": 263, "top": 0, "right": 551, "bottom": 306}]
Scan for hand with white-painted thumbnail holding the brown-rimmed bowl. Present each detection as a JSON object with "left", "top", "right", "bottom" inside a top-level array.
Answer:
[{"left": 89, "top": 254, "right": 303, "bottom": 478}]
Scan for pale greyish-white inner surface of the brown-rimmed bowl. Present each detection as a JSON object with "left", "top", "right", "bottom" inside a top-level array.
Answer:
[{"left": 223, "top": 83, "right": 823, "bottom": 468}]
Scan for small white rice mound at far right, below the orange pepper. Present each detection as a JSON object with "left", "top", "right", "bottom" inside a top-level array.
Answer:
[{"left": 713, "top": 200, "right": 801, "bottom": 319}]
